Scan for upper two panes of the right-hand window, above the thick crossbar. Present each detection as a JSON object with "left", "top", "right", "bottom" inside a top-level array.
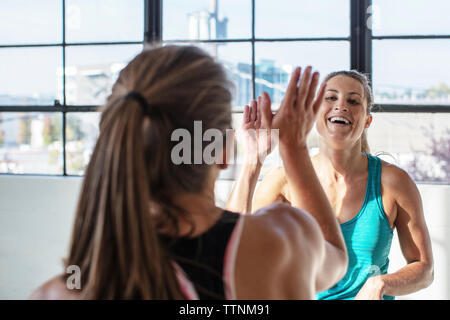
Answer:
[{"left": 372, "top": 0, "right": 450, "bottom": 106}]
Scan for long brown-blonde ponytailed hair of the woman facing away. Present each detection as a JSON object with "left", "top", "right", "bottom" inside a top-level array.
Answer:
[{"left": 66, "top": 46, "right": 232, "bottom": 299}]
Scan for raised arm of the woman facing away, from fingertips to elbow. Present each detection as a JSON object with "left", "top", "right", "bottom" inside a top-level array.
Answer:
[{"left": 274, "top": 68, "right": 348, "bottom": 291}]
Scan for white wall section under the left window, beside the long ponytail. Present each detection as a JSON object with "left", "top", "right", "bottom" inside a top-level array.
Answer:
[{"left": 0, "top": 176, "right": 81, "bottom": 299}]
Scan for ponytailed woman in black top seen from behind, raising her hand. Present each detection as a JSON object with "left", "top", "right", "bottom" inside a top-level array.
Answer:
[{"left": 31, "top": 46, "right": 347, "bottom": 299}]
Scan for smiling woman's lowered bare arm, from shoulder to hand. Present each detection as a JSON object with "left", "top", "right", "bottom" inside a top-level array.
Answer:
[{"left": 358, "top": 166, "right": 434, "bottom": 299}]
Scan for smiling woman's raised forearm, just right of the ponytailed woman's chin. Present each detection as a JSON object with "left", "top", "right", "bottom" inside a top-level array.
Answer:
[{"left": 225, "top": 162, "right": 262, "bottom": 213}]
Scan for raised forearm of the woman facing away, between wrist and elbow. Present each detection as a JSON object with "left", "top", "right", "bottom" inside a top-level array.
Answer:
[{"left": 280, "top": 146, "right": 346, "bottom": 252}]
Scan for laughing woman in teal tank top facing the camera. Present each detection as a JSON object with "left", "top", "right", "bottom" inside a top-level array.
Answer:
[{"left": 230, "top": 71, "right": 433, "bottom": 300}]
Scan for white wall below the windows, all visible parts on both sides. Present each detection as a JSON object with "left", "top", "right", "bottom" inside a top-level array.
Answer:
[{"left": 0, "top": 176, "right": 450, "bottom": 299}]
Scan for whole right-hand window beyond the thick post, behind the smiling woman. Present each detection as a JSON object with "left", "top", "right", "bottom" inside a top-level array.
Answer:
[{"left": 368, "top": 0, "right": 450, "bottom": 184}]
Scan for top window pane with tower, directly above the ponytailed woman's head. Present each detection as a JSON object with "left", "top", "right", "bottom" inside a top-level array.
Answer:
[{"left": 163, "top": 0, "right": 252, "bottom": 40}]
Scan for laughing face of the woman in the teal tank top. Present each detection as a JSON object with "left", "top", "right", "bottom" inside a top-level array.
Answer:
[{"left": 316, "top": 75, "right": 372, "bottom": 149}]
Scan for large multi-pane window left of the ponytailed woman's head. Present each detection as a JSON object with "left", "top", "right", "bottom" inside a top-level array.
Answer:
[{"left": 0, "top": 0, "right": 144, "bottom": 175}]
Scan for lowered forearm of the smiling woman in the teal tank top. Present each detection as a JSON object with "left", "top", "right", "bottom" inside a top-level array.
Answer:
[{"left": 379, "top": 261, "right": 434, "bottom": 296}]
